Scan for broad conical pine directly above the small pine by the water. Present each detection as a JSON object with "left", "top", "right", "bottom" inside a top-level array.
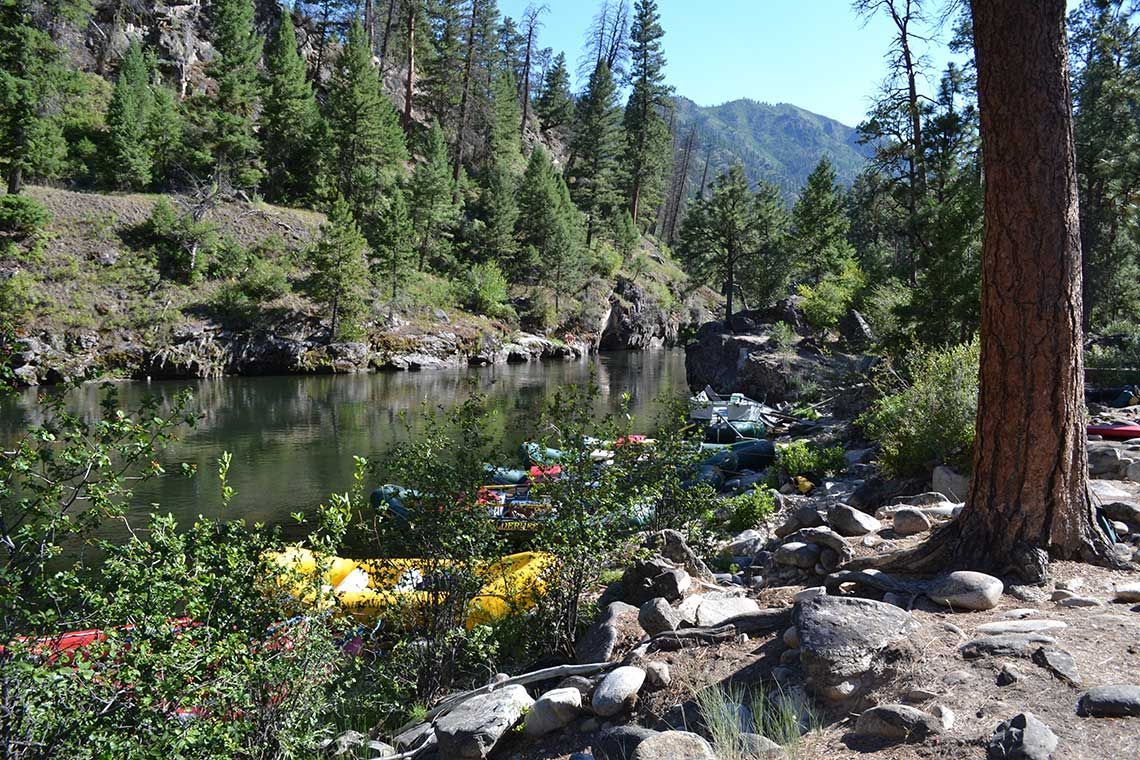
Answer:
[{"left": 328, "top": 22, "right": 408, "bottom": 226}]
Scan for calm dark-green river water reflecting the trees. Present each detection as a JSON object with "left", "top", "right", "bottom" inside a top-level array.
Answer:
[{"left": 0, "top": 351, "right": 687, "bottom": 540}]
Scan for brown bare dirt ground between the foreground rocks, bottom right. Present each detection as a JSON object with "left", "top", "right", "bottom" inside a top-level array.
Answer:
[{"left": 495, "top": 563, "right": 1140, "bottom": 760}]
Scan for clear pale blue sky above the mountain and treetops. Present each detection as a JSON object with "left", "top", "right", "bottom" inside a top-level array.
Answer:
[{"left": 499, "top": 0, "right": 1075, "bottom": 126}]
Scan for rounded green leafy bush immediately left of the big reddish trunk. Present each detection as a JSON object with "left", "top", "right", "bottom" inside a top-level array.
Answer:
[{"left": 857, "top": 340, "right": 979, "bottom": 476}]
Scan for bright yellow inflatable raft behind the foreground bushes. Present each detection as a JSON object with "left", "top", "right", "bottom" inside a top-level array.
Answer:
[{"left": 270, "top": 547, "right": 551, "bottom": 630}]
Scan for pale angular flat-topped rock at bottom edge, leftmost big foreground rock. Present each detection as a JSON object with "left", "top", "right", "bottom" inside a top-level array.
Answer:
[{"left": 435, "top": 685, "right": 535, "bottom": 758}]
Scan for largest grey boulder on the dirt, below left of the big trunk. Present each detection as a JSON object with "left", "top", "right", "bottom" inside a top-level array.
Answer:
[{"left": 792, "top": 596, "right": 919, "bottom": 702}]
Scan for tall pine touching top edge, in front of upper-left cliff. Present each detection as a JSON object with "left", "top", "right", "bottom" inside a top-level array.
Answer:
[{"left": 206, "top": 0, "right": 263, "bottom": 189}]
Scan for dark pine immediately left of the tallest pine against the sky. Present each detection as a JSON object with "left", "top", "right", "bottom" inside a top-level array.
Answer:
[{"left": 570, "top": 62, "right": 621, "bottom": 247}]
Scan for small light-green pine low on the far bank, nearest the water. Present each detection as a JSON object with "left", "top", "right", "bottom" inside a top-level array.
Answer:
[{"left": 309, "top": 198, "right": 369, "bottom": 342}]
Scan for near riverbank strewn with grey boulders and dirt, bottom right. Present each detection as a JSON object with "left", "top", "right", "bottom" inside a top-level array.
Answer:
[{"left": 344, "top": 432, "right": 1140, "bottom": 760}]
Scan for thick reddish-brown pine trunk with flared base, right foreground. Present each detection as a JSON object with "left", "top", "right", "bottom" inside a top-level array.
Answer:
[{"left": 852, "top": 0, "right": 1122, "bottom": 582}]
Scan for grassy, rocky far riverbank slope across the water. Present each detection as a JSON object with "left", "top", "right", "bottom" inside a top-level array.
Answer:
[{"left": 0, "top": 188, "right": 717, "bottom": 385}]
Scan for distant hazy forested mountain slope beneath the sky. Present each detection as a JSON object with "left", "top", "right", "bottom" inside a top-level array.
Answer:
[{"left": 675, "top": 97, "right": 870, "bottom": 201}]
